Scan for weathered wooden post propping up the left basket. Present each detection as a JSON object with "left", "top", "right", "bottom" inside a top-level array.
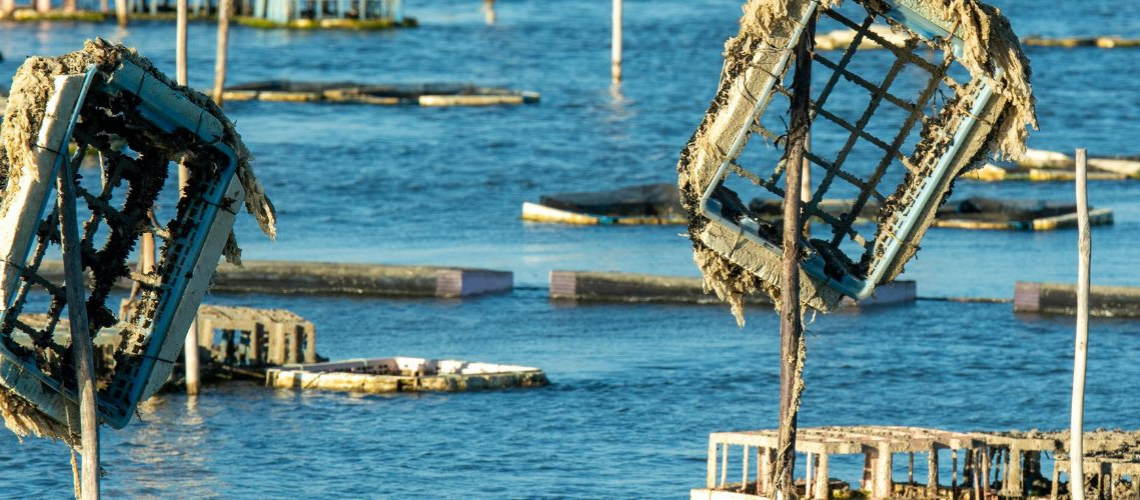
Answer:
[{"left": 57, "top": 130, "right": 99, "bottom": 500}]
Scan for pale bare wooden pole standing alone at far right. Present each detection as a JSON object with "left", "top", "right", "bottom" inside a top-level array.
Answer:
[{"left": 1069, "top": 148, "right": 1092, "bottom": 500}]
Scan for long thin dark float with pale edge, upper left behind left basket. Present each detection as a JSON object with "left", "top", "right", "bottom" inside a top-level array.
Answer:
[{"left": 222, "top": 80, "right": 539, "bottom": 106}]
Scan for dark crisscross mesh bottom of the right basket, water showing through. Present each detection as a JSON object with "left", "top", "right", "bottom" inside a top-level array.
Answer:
[{"left": 716, "top": 5, "right": 969, "bottom": 282}]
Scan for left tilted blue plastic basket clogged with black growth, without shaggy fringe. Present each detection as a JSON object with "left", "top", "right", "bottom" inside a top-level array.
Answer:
[{"left": 0, "top": 42, "right": 261, "bottom": 428}]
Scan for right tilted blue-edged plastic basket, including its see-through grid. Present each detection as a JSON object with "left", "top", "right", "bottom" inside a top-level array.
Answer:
[{"left": 678, "top": 0, "right": 1032, "bottom": 311}]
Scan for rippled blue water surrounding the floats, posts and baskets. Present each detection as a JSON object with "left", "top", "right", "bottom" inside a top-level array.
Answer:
[{"left": 0, "top": 0, "right": 1140, "bottom": 498}]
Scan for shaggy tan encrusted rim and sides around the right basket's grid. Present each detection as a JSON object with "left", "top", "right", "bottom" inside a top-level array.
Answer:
[{"left": 677, "top": 0, "right": 1036, "bottom": 323}]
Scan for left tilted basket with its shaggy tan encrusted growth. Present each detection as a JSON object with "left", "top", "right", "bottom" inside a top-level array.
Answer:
[{"left": 0, "top": 39, "right": 276, "bottom": 444}]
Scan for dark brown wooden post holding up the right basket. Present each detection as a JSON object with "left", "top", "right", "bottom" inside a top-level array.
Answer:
[{"left": 771, "top": 11, "right": 815, "bottom": 499}]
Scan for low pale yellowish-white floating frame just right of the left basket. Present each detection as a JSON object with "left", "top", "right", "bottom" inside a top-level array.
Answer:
[{"left": 266, "top": 358, "right": 549, "bottom": 394}]
